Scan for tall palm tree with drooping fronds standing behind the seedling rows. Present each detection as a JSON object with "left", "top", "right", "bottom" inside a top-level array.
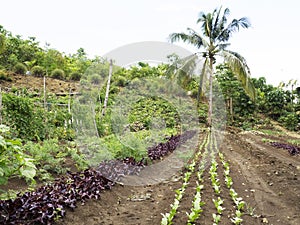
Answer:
[{"left": 170, "top": 7, "right": 255, "bottom": 127}]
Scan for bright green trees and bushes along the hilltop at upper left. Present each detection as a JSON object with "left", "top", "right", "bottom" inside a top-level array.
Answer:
[{"left": 0, "top": 25, "right": 92, "bottom": 79}]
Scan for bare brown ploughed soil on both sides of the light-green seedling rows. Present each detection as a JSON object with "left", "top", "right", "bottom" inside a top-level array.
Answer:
[{"left": 57, "top": 129, "right": 300, "bottom": 225}]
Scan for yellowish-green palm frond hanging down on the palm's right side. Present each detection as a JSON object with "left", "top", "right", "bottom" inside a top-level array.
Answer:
[{"left": 220, "top": 50, "right": 256, "bottom": 100}]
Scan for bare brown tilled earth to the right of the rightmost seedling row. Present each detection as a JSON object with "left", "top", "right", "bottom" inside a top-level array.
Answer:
[{"left": 222, "top": 133, "right": 300, "bottom": 225}]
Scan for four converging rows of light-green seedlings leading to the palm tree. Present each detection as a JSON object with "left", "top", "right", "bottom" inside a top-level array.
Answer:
[{"left": 161, "top": 133, "right": 250, "bottom": 225}]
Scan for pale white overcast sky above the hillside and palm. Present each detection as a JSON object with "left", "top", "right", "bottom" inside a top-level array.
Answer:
[{"left": 0, "top": 0, "right": 300, "bottom": 85}]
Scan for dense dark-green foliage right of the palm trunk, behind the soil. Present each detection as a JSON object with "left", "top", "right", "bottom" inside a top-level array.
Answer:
[{"left": 216, "top": 64, "right": 300, "bottom": 131}]
